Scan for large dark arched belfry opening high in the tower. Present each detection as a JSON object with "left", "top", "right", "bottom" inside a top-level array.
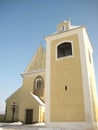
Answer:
[{"left": 57, "top": 42, "right": 72, "bottom": 58}]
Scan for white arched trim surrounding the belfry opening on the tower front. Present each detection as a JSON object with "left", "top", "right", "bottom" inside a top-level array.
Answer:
[{"left": 55, "top": 40, "right": 74, "bottom": 61}]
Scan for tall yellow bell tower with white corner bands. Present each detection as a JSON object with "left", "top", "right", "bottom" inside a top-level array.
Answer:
[{"left": 45, "top": 21, "right": 98, "bottom": 128}]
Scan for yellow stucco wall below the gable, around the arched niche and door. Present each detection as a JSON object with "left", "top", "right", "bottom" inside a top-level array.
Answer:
[{"left": 6, "top": 72, "right": 45, "bottom": 122}]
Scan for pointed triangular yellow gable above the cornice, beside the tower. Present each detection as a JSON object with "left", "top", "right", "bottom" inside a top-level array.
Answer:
[{"left": 25, "top": 45, "right": 46, "bottom": 72}]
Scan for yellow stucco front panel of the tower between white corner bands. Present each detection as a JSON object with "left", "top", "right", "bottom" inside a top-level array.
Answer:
[{"left": 50, "top": 35, "right": 85, "bottom": 122}]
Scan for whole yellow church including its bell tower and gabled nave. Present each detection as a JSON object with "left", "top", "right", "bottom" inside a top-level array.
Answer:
[{"left": 6, "top": 21, "right": 98, "bottom": 129}]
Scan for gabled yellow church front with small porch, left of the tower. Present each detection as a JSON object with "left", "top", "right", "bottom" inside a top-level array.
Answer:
[{"left": 5, "top": 45, "right": 46, "bottom": 124}]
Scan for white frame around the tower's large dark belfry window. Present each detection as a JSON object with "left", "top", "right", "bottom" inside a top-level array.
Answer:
[{"left": 56, "top": 40, "right": 74, "bottom": 60}]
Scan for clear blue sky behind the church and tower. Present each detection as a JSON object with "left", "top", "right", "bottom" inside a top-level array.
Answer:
[{"left": 0, "top": 0, "right": 98, "bottom": 112}]
